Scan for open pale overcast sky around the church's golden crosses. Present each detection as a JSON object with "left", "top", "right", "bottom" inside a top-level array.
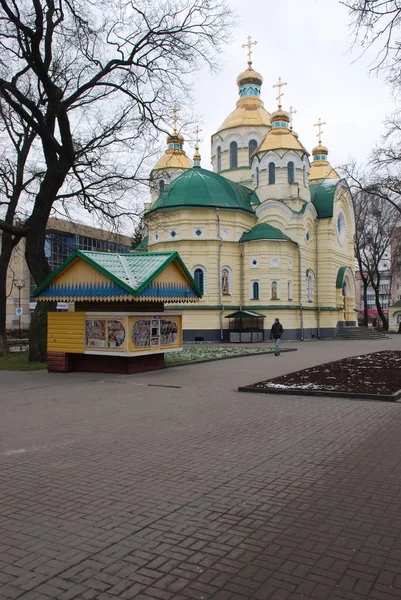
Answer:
[{"left": 185, "top": 0, "right": 395, "bottom": 169}]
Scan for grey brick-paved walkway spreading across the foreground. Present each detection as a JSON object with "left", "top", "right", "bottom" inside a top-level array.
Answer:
[{"left": 0, "top": 336, "right": 401, "bottom": 600}]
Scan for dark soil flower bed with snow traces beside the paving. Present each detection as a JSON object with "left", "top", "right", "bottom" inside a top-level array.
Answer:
[{"left": 239, "top": 350, "right": 401, "bottom": 400}]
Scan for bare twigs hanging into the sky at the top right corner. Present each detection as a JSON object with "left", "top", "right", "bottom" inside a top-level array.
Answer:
[{"left": 341, "top": 0, "right": 401, "bottom": 89}]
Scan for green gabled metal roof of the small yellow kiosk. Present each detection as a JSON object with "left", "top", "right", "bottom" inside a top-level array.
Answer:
[{"left": 33, "top": 250, "right": 202, "bottom": 298}]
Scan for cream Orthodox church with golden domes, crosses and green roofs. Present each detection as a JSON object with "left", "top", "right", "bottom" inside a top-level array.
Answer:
[{"left": 142, "top": 38, "right": 356, "bottom": 341}]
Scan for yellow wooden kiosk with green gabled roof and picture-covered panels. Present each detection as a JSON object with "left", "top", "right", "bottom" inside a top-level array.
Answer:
[{"left": 33, "top": 250, "right": 201, "bottom": 373}]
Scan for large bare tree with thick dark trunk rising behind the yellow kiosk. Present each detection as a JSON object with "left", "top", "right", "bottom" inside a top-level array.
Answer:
[{"left": 0, "top": 0, "right": 231, "bottom": 360}]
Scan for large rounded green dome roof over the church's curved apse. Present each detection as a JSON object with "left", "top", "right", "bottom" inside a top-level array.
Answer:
[{"left": 147, "top": 167, "right": 260, "bottom": 214}]
